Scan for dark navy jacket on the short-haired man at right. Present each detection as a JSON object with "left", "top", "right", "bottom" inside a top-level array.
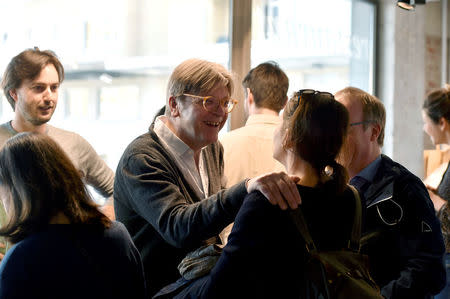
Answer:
[{"left": 362, "top": 155, "right": 445, "bottom": 299}]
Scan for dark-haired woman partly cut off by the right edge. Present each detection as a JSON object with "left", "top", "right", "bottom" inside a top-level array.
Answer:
[{"left": 422, "top": 86, "right": 450, "bottom": 299}]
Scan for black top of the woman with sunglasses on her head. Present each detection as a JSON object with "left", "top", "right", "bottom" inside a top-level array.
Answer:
[{"left": 177, "top": 186, "right": 355, "bottom": 298}]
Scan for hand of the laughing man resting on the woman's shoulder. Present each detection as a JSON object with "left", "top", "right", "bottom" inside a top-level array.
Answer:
[{"left": 247, "top": 172, "right": 302, "bottom": 210}]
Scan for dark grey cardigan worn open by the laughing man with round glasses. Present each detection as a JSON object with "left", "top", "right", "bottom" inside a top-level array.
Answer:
[{"left": 114, "top": 129, "right": 247, "bottom": 295}]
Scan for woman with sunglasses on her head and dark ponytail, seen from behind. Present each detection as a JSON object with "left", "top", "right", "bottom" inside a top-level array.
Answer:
[{"left": 166, "top": 90, "right": 355, "bottom": 298}]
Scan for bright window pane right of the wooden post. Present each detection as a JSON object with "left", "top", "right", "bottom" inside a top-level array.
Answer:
[{"left": 251, "top": 0, "right": 375, "bottom": 94}]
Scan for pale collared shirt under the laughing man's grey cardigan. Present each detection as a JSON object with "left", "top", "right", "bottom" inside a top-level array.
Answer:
[{"left": 154, "top": 115, "right": 210, "bottom": 199}]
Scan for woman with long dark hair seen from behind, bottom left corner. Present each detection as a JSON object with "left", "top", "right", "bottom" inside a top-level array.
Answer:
[{"left": 0, "top": 133, "right": 146, "bottom": 299}]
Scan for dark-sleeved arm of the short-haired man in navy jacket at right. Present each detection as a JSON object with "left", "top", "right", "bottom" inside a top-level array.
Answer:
[{"left": 381, "top": 181, "right": 445, "bottom": 298}]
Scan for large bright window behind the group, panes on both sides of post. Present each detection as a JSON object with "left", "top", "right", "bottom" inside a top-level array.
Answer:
[{"left": 0, "top": 0, "right": 375, "bottom": 177}]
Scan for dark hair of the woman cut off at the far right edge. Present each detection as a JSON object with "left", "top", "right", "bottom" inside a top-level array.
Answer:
[{"left": 422, "top": 85, "right": 450, "bottom": 124}]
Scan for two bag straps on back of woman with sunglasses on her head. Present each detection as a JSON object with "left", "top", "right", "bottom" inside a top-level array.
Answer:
[{"left": 290, "top": 185, "right": 362, "bottom": 252}]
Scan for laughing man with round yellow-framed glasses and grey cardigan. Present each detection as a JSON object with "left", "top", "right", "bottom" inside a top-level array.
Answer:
[{"left": 114, "top": 59, "right": 300, "bottom": 295}]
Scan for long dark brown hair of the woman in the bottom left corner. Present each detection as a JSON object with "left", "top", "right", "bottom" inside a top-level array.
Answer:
[{"left": 0, "top": 133, "right": 110, "bottom": 243}]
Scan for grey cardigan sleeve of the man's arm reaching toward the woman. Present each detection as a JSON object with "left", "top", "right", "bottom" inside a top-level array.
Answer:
[{"left": 115, "top": 151, "right": 247, "bottom": 247}]
